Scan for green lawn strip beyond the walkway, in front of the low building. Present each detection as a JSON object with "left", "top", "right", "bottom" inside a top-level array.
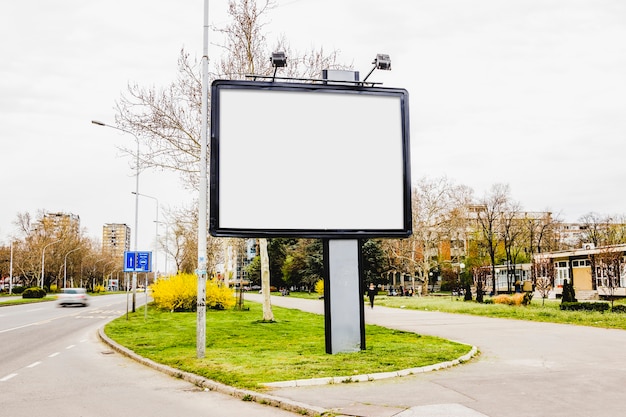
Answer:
[{"left": 376, "top": 295, "right": 626, "bottom": 330}]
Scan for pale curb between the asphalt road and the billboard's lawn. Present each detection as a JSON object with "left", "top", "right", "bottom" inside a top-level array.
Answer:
[{"left": 98, "top": 327, "right": 329, "bottom": 416}]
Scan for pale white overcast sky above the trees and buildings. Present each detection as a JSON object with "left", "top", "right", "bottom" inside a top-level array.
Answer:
[{"left": 0, "top": 0, "right": 626, "bottom": 270}]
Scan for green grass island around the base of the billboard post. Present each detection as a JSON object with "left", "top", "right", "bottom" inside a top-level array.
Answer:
[{"left": 105, "top": 302, "right": 471, "bottom": 389}]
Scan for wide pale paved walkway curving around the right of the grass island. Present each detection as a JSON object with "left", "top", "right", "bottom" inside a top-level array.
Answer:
[{"left": 246, "top": 294, "right": 626, "bottom": 417}]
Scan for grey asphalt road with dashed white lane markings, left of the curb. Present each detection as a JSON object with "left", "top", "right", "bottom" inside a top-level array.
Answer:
[{"left": 0, "top": 294, "right": 294, "bottom": 417}]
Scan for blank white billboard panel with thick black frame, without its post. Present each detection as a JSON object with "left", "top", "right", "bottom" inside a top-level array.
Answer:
[{"left": 209, "top": 80, "right": 411, "bottom": 238}]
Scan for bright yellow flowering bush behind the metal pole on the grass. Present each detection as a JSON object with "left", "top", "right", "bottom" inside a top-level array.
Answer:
[{"left": 151, "top": 274, "right": 235, "bottom": 311}]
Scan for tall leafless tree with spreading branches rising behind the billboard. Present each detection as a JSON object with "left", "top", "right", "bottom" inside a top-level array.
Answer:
[{"left": 116, "top": 0, "right": 346, "bottom": 318}]
